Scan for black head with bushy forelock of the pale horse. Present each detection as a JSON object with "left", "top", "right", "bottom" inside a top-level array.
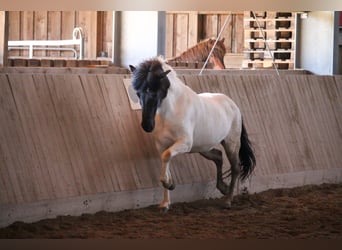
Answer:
[{"left": 129, "top": 60, "right": 170, "bottom": 132}]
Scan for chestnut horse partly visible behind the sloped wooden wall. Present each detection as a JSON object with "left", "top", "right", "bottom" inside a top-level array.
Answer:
[{"left": 167, "top": 38, "right": 226, "bottom": 69}]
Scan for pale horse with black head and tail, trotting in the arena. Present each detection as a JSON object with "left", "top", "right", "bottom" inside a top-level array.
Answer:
[{"left": 129, "top": 57, "right": 256, "bottom": 211}]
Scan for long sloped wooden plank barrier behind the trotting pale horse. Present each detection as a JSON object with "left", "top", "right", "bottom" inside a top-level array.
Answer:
[{"left": 0, "top": 72, "right": 342, "bottom": 226}]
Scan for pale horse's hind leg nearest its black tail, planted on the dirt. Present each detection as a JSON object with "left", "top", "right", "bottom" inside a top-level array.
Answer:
[{"left": 221, "top": 140, "right": 240, "bottom": 208}]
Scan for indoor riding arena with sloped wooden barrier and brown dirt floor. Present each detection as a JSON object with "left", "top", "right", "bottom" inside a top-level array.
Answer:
[{"left": 0, "top": 11, "right": 342, "bottom": 239}]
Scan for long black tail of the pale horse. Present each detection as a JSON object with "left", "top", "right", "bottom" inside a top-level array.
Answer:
[{"left": 239, "top": 121, "right": 256, "bottom": 181}]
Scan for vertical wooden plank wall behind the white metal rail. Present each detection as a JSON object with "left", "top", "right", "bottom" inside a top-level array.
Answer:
[{"left": 9, "top": 11, "right": 113, "bottom": 58}]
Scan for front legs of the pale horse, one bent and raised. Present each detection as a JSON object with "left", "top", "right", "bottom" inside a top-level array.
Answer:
[{"left": 159, "top": 140, "right": 191, "bottom": 210}]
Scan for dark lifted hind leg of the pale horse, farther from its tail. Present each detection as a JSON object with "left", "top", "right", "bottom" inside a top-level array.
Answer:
[{"left": 200, "top": 148, "right": 229, "bottom": 195}]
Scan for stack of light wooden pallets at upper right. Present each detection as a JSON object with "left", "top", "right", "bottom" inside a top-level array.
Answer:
[{"left": 243, "top": 11, "right": 296, "bottom": 69}]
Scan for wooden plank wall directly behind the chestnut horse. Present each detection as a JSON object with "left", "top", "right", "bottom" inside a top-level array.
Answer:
[{"left": 165, "top": 11, "right": 244, "bottom": 58}]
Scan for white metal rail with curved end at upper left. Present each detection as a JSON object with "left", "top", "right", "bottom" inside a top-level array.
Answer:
[{"left": 8, "top": 27, "right": 84, "bottom": 60}]
